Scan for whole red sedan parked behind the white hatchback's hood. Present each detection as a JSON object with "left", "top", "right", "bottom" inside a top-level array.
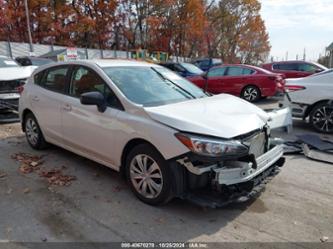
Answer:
[{"left": 188, "top": 64, "right": 285, "bottom": 102}]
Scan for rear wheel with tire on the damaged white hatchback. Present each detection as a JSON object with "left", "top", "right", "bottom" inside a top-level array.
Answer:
[{"left": 24, "top": 113, "right": 48, "bottom": 150}]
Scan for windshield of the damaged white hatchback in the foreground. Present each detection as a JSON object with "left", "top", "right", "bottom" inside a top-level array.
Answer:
[{"left": 103, "top": 65, "right": 207, "bottom": 106}]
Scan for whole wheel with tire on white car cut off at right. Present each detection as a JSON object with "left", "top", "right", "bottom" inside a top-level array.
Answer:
[{"left": 309, "top": 103, "right": 333, "bottom": 133}]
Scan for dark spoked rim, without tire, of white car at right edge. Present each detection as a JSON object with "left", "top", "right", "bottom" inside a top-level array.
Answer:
[{"left": 312, "top": 105, "right": 333, "bottom": 132}]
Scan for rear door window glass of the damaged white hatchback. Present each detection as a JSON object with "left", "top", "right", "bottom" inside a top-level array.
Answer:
[{"left": 39, "top": 66, "right": 69, "bottom": 93}]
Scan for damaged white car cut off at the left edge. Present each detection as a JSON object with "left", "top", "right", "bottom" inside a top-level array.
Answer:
[{"left": 0, "top": 56, "right": 37, "bottom": 111}]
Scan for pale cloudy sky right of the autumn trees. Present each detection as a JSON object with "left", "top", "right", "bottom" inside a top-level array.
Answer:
[{"left": 259, "top": 0, "right": 333, "bottom": 61}]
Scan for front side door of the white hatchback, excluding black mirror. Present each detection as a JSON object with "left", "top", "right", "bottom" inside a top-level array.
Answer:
[{"left": 62, "top": 66, "right": 123, "bottom": 165}]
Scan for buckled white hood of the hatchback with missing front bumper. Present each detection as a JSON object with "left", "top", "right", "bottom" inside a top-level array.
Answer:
[{"left": 144, "top": 94, "right": 269, "bottom": 138}]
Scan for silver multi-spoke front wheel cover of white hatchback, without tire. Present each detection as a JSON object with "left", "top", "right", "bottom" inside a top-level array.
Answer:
[{"left": 130, "top": 154, "right": 163, "bottom": 199}]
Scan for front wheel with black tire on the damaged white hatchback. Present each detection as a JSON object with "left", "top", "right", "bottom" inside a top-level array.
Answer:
[{"left": 126, "top": 144, "right": 173, "bottom": 205}]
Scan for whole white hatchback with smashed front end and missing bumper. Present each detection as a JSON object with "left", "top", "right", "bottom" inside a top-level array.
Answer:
[{"left": 19, "top": 60, "right": 284, "bottom": 205}]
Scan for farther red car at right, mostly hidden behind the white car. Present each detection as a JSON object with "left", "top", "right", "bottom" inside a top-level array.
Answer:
[{"left": 262, "top": 61, "right": 327, "bottom": 78}]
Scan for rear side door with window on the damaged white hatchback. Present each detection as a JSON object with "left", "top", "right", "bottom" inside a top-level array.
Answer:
[{"left": 29, "top": 65, "right": 70, "bottom": 143}]
